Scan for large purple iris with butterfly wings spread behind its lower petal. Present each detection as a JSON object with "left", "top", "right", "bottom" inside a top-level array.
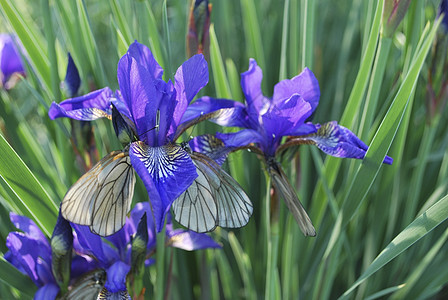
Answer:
[{"left": 49, "top": 42, "right": 213, "bottom": 231}]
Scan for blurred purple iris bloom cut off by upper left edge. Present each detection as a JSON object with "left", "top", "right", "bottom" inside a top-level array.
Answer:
[{"left": 0, "top": 33, "right": 25, "bottom": 89}]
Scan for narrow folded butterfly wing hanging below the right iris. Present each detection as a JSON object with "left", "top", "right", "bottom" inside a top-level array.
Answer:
[{"left": 268, "top": 161, "right": 316, "bottom": 236}]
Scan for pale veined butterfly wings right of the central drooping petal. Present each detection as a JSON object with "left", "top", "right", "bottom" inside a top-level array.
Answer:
[{"left": 172, "top": 152, "right": 253, "bottom": 232}]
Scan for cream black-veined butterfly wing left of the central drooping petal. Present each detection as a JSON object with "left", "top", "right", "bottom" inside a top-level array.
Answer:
[{"left": 61, "top": 151, "right": 135, "bottom": 236}]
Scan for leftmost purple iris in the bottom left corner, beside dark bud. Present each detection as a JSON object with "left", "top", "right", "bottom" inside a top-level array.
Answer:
[{"left": 5, "top": 212, "right": 94, "bottom": 299}]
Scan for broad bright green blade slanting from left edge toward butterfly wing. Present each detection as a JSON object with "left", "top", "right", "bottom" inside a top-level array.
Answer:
[{"left": 0, "top": 135, "right": 58, "bottom": 236}]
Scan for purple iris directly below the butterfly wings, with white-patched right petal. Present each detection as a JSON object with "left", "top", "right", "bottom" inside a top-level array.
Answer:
[{"left": 72, "top": 202, "right": 221, "bottom": 293}]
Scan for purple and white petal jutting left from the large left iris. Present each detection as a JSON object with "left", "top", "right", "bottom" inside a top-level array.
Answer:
[{"left": 48, "top": 87, "right": 114, "bottom": 121}]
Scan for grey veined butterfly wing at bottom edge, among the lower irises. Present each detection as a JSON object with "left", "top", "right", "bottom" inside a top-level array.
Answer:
[{"left": 62, "top": 269, "right": 106, "bottom": 300}]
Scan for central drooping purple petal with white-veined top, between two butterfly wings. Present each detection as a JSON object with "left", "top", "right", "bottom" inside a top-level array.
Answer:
[{"left": 129, "top": 142, "right": 198, "bottom": 231}]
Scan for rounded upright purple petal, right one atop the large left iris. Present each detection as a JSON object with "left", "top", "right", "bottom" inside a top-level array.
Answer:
[{"left": 173, "top": 55, "right": 208, "bottom": 127}]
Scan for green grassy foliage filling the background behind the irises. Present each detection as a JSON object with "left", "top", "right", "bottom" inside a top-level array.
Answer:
[{"left": 0, "top": 0, "right": 448, "bottom": 299}]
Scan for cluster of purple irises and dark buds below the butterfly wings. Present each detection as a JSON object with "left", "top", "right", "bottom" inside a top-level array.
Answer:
[{"left": 5, "top": 202, "right": 220, "bottom": 299}]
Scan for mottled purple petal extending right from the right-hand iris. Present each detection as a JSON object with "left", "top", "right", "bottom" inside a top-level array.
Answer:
[{"left": 299, "top": 121, "right": 393, "bottom": 164}]
